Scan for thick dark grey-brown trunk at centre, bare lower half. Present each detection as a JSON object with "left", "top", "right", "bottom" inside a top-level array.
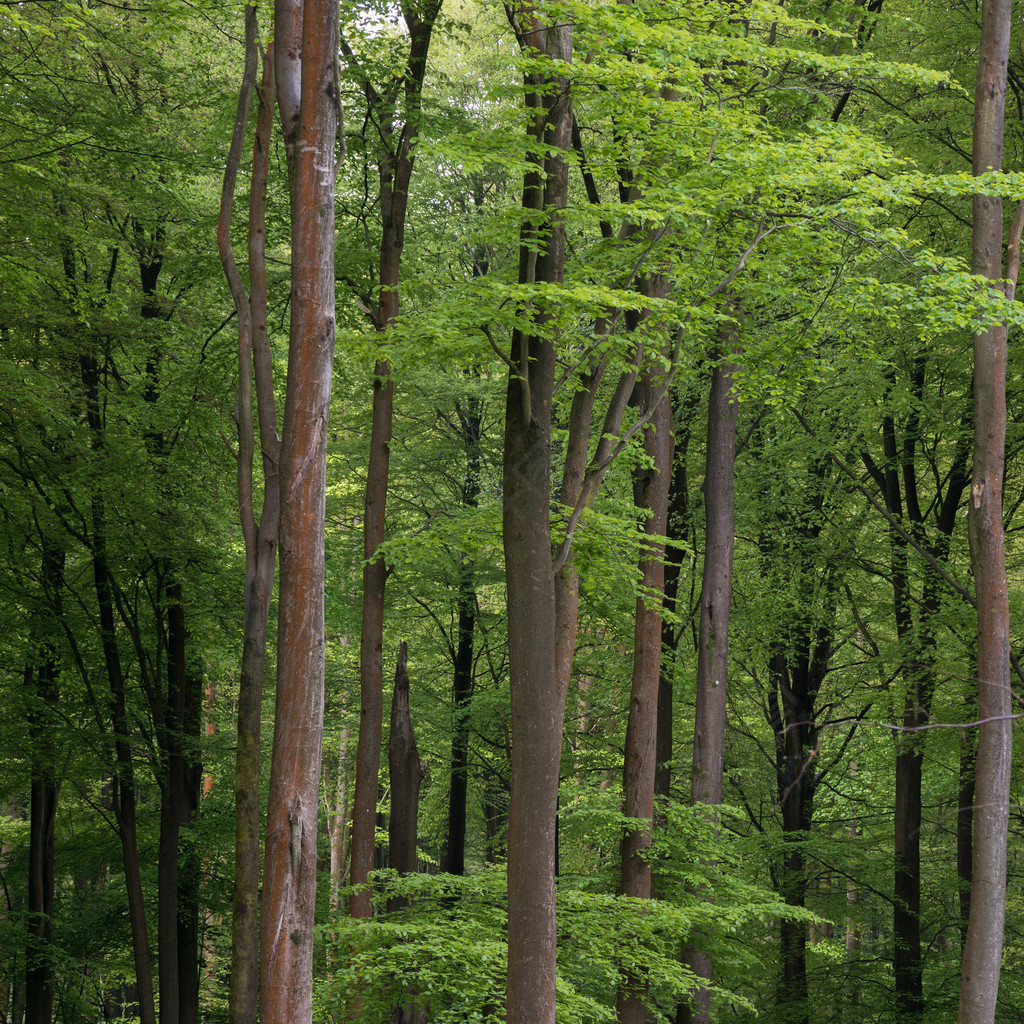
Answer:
[{"left": 502, "top": 7, "right": 572, "bottom": 1024}]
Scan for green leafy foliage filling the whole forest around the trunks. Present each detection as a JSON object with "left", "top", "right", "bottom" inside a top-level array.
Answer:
[{"left": 0, "top": 0, "right": 1024, "bottom": 1024}]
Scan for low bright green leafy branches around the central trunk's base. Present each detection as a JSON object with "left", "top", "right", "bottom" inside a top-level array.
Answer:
[{"left": 316, "top": 819, "right": 798, "bottom": 1024}]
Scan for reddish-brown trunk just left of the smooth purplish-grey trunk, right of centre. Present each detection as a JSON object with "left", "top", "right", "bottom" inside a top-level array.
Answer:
[{"left": 615, "top": 372, "right": 673, "bottom": 1024}]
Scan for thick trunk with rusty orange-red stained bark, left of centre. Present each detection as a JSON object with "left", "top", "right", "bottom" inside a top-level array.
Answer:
[{"left": 260, "top": 0, "right": 338, "bottom": 1024}]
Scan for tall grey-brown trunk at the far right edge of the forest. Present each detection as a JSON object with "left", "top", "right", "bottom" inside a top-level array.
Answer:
[{"left": 959, "top": 0, "right": 1020, "bottom": 1024}]
